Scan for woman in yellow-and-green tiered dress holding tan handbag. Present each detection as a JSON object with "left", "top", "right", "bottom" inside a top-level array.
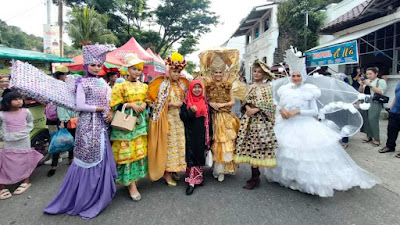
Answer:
[{"left": 110, "top": 54, "right": 148, "bottom": 201}]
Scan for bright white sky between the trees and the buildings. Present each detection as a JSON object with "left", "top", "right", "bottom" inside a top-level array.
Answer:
[{"left": 0, "top": 0, "right": 267, "bottom": 62}]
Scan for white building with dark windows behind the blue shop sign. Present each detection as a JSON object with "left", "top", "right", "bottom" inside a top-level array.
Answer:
[{"left": 309, "top": 0, "right": 400, "bottom": 107}]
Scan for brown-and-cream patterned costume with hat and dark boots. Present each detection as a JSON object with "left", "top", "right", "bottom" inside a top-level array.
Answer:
[{"left": 234, "top": 61, "right": 277, "bottom": 189}]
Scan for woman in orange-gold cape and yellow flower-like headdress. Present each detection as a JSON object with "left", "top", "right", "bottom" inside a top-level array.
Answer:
[{"left": 148, "top": 53, "right": 189, "bottom": 186}]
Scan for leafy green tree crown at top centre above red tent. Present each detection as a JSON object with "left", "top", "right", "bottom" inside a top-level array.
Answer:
[{"left": 60, "top": 0, "right": 218, "bottom": 56}]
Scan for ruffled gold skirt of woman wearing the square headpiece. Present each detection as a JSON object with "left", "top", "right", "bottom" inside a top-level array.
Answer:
[{"left": 211, "top": 112, "right": 240, "bottom": 174}]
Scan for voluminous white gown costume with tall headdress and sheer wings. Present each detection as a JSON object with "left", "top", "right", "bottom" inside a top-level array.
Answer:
[{"left": 266, "top": 47, "right": 379, "bottom": 197}]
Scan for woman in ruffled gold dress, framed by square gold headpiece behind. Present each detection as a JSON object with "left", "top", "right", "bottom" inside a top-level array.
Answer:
[{"left": 205, "top": 56, "right": 240, "bottom": 182}]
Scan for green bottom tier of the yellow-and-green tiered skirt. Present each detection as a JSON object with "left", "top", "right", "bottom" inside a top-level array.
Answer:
[{"left": 115, "top": 157, "right": 148, "bottom": 186}]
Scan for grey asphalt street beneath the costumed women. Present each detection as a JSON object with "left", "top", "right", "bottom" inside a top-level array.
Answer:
[{"left": 0, "top": 121, "right": 400, "bottom": 225}]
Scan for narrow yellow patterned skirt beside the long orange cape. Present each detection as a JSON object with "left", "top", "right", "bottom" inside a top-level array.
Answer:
[{"left": 165, "top": 108, "right": 186, "bottom": 172}]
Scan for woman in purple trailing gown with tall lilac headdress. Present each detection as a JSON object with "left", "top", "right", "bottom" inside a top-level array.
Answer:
[{"left": 44, "top": 45, "right": 117, "bottom": 219}]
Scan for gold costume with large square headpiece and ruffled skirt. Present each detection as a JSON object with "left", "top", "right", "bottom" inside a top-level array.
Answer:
[{"left": 199, "top": 49, "right": 245, "bottom": 181}]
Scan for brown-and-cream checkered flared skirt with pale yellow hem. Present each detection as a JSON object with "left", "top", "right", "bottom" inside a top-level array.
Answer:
[{"left": 234, "top": 113, "right": 277, "bottom": 167}]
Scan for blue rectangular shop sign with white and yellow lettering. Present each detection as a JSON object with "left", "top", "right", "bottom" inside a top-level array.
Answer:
[{"left": 305, "top": 41, "right": 358, "bottom": 67}]
